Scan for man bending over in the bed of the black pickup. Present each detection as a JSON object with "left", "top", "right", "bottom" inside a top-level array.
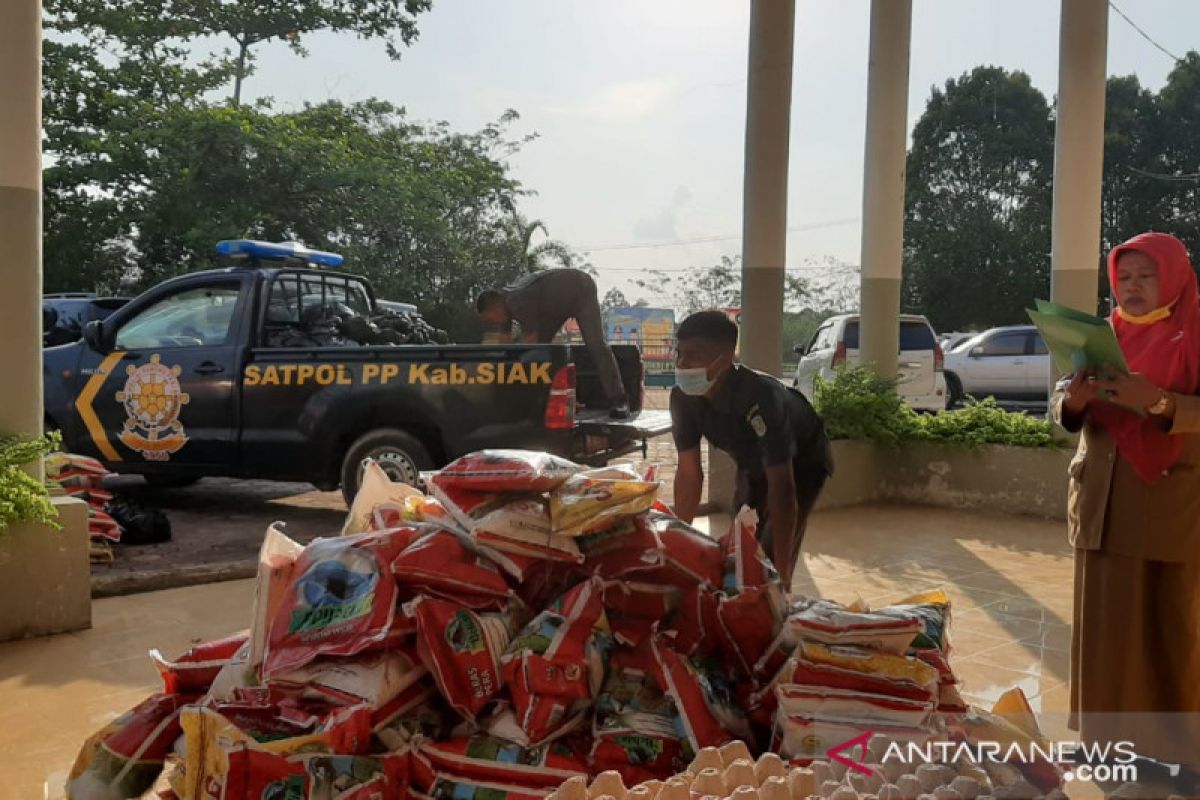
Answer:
[{"left": 475, "top": 267, "right": 629, "bottom": 419}]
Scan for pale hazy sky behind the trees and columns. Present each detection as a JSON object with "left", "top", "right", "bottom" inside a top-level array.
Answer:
[{"left": 246, "top": 0, "right": 1200, "bottom": 300}]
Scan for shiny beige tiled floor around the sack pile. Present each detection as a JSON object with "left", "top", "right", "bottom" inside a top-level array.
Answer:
[{"left": 0, "top": 507, "right": 1072, "bottom": 800}]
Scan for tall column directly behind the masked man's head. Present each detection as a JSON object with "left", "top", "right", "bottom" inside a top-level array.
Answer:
[{"left": 740, "top": 0, "right": 796, "bottom": 375}]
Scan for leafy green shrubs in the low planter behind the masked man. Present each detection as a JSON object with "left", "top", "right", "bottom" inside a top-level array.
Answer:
[{"left": 812, "top": 367, "right": 1063, "bottom": 447}]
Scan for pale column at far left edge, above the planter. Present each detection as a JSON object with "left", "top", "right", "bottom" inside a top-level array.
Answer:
[{"left": 0, "top": 0, "right": 42, "bottom": 474}]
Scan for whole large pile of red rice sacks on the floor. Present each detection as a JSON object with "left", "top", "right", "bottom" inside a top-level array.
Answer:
[{"left": 67, "top": 451, "right": 1060, "bottom": 800}]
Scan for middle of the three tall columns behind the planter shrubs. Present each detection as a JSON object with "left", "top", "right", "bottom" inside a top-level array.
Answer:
[{"left": 859, "top": 0, "right": 912, "bottom": 378}]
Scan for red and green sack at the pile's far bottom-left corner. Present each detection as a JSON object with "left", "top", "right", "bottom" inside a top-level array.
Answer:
[{"left": 67, "top": 694, "right": 196, "bottom": 800}]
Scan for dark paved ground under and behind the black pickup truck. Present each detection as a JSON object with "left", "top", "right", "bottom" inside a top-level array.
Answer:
[{"left": 92, "top": 390, "right": 696, "bottom": 597}]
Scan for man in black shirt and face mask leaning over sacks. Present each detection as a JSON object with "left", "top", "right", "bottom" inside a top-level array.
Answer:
[{"left": 671, "top": 311, "right": 833, "bottom": 588}]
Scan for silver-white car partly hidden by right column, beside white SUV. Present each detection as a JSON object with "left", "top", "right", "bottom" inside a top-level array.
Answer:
[{"left": 946, "top": 325, "right": 1050, "bottom": 404}]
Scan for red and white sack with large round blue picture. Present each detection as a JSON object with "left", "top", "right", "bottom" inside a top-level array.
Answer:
[{"left": 263, "top": 528, "right": 420, "bottom": 676}]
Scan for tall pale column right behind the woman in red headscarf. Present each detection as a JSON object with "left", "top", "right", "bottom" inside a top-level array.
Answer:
[{"left": 1050, "top": 0, "right": 1109, "bottom": 313}]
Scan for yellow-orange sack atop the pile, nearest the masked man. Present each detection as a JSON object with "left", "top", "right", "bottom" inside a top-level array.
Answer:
[{"left": 550, "top": 467, "right": 659, "bottom": 536}]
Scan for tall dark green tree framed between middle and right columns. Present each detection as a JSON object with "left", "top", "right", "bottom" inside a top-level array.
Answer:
[{"left": 904, "top": 67, "right": 1054, "bottom": 330}]
